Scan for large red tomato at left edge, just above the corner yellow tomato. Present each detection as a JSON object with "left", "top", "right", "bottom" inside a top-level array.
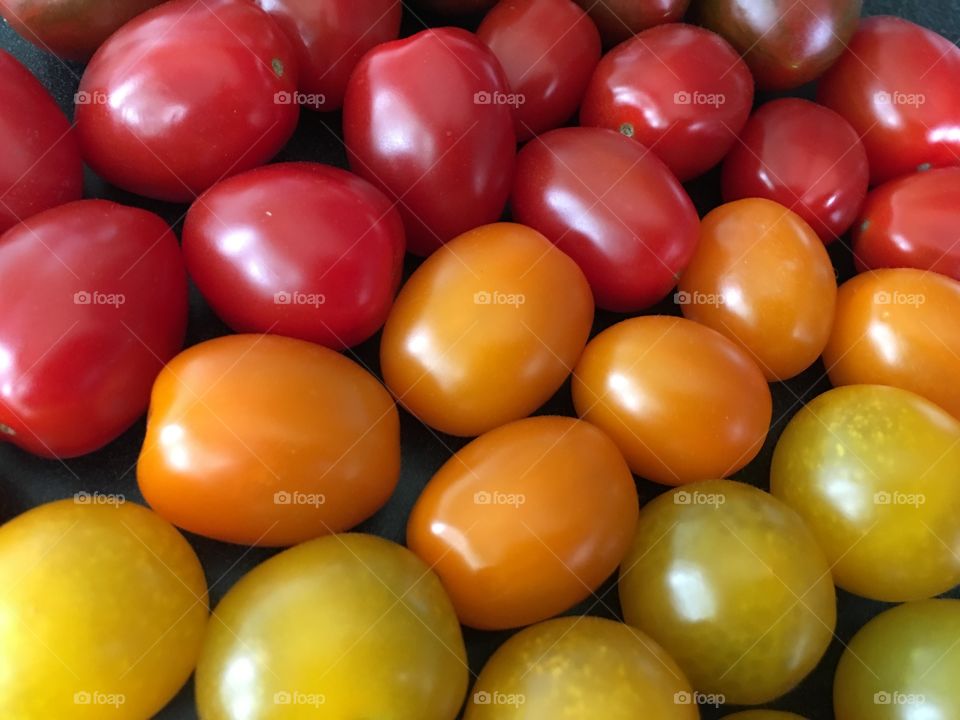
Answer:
[{"left": 0, "top": 200, "right": 187, "bottom": 457}]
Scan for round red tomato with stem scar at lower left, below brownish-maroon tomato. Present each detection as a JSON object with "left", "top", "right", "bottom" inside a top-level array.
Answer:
[{"left": 580, "top": 23, "right": 753, "bottom": 180}]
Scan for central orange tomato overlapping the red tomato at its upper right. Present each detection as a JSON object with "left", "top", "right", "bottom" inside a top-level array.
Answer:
[{"left": 380, "top": 223, "right": 593, "bottom": 436}]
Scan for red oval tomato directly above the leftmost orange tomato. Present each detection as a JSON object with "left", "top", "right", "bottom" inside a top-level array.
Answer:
[{"left": 183, "top": 163, "right": 404, "bottom": 349}]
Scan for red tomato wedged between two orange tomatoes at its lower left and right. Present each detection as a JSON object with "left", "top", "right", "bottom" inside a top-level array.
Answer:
[{"left": 512, "top": 128, "right": 699, "bottom": 312}]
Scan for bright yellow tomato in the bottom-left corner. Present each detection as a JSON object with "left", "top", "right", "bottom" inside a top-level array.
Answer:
[{"left": 0, "top": 494, "right": 208, "bottom": 720}]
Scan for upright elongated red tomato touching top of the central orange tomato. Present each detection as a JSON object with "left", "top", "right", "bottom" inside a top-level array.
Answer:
[{"left": 343, "top": 28, "right": 516, "bottom": 255}]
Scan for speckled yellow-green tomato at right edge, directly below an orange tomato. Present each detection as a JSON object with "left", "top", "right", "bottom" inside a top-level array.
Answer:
[{"left": 770, "top": 385, "right": 960, "bottom": 602}]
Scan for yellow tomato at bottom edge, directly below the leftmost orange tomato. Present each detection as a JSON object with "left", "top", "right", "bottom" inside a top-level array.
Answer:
[{"left": 196, "top": 533, "right": 468, "bottom": 720}]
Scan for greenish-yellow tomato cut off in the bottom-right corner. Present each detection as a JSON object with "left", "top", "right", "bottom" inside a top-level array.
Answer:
[{"left": 833, "top": 600, "right": 960, "bottom": 720}]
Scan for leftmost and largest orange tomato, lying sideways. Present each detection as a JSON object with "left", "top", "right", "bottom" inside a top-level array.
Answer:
[{"left": 137, "top": 335, "right": 400, "bottom": 546}]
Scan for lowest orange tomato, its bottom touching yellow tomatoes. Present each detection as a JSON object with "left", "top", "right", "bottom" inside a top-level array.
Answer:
[{"left": 407, "top": 416, "right": 639, "bottom": 630}]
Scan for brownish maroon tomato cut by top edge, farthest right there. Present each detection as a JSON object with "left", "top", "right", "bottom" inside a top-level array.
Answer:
[{"left": 697, "top": 0, "right": 863, "bottom": 90}]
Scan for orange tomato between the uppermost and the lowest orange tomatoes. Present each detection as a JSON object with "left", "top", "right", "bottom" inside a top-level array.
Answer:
[{"left": 572, "top": 315, "right": 772, "bottom": 485}]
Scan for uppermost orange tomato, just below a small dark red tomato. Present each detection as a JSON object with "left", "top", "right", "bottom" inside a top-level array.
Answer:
[{"left": 677, "top": 198, "right": 837, "bottom": 380}]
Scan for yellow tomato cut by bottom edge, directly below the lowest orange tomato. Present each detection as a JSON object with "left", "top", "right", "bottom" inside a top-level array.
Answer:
[{"left": 464, "top": 616, "right": 699, "bottom": 720}]
